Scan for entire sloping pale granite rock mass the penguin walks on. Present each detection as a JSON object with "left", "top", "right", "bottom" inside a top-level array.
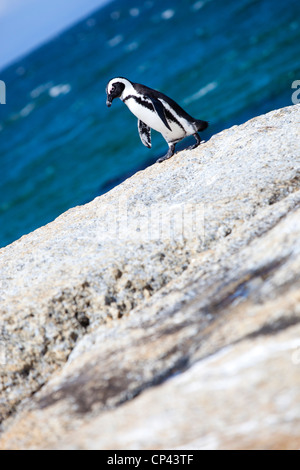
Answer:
[{"left": 0, "top": 105, "right": 300, "bottom": 449}]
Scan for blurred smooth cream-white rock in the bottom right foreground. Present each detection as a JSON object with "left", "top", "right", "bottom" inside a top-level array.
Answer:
[{"left": 60, "top": 324, "right": 300, "bottom": 449}]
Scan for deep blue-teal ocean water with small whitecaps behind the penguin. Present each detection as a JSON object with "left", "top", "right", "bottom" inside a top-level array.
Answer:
[{"left": 0, "top": 0, "right": 300, "bottom": 247}]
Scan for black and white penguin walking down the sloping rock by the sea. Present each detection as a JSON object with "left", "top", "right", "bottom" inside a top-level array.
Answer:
[{"left": 106, "top": 77, "right": 208, "bottom": 163}]
